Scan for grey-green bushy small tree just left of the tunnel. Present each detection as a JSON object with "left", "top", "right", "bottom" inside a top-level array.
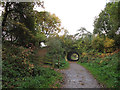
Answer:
[{"left": 47, "top": 37, "right": 64, "bottom": 68}]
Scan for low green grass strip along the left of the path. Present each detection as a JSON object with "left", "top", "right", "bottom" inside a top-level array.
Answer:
[{"left": 3, "top": 64, "right": 62, "bottom": 88}]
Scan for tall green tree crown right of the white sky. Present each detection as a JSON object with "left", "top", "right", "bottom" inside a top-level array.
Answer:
[{"left": 94, "top": 2, "right": 118, "bottom": 37}]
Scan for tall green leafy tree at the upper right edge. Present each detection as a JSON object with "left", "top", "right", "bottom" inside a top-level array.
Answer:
[{"left": 94, "top": 2, "right": 120, "bottom": 47}]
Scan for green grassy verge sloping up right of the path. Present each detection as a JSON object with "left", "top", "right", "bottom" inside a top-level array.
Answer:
[{"left": 78, "top": 53, "right": 120, "bottom": 88}]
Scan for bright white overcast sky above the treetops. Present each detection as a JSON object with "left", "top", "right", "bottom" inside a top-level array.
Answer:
[{"left": 37, "top": 0, "right": 107, "bottom": 35}]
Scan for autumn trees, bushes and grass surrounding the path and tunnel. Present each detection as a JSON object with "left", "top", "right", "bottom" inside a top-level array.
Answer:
[{"left": 0, "top": 2, "right": 120, "bottom": 88}]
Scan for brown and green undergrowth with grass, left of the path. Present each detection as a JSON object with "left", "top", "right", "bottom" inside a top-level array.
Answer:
[{"left": 2, "top": 44, "right": 62, "bottom": 88}]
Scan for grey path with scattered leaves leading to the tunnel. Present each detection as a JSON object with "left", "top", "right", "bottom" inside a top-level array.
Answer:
[{"left": 61, "top": 62, "right": 100, "bottom": 88}]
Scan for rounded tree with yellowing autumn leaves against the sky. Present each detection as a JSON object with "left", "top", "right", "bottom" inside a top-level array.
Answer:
[{"left": 35, "top": 11, "right": 61, "bottom": 36}]
